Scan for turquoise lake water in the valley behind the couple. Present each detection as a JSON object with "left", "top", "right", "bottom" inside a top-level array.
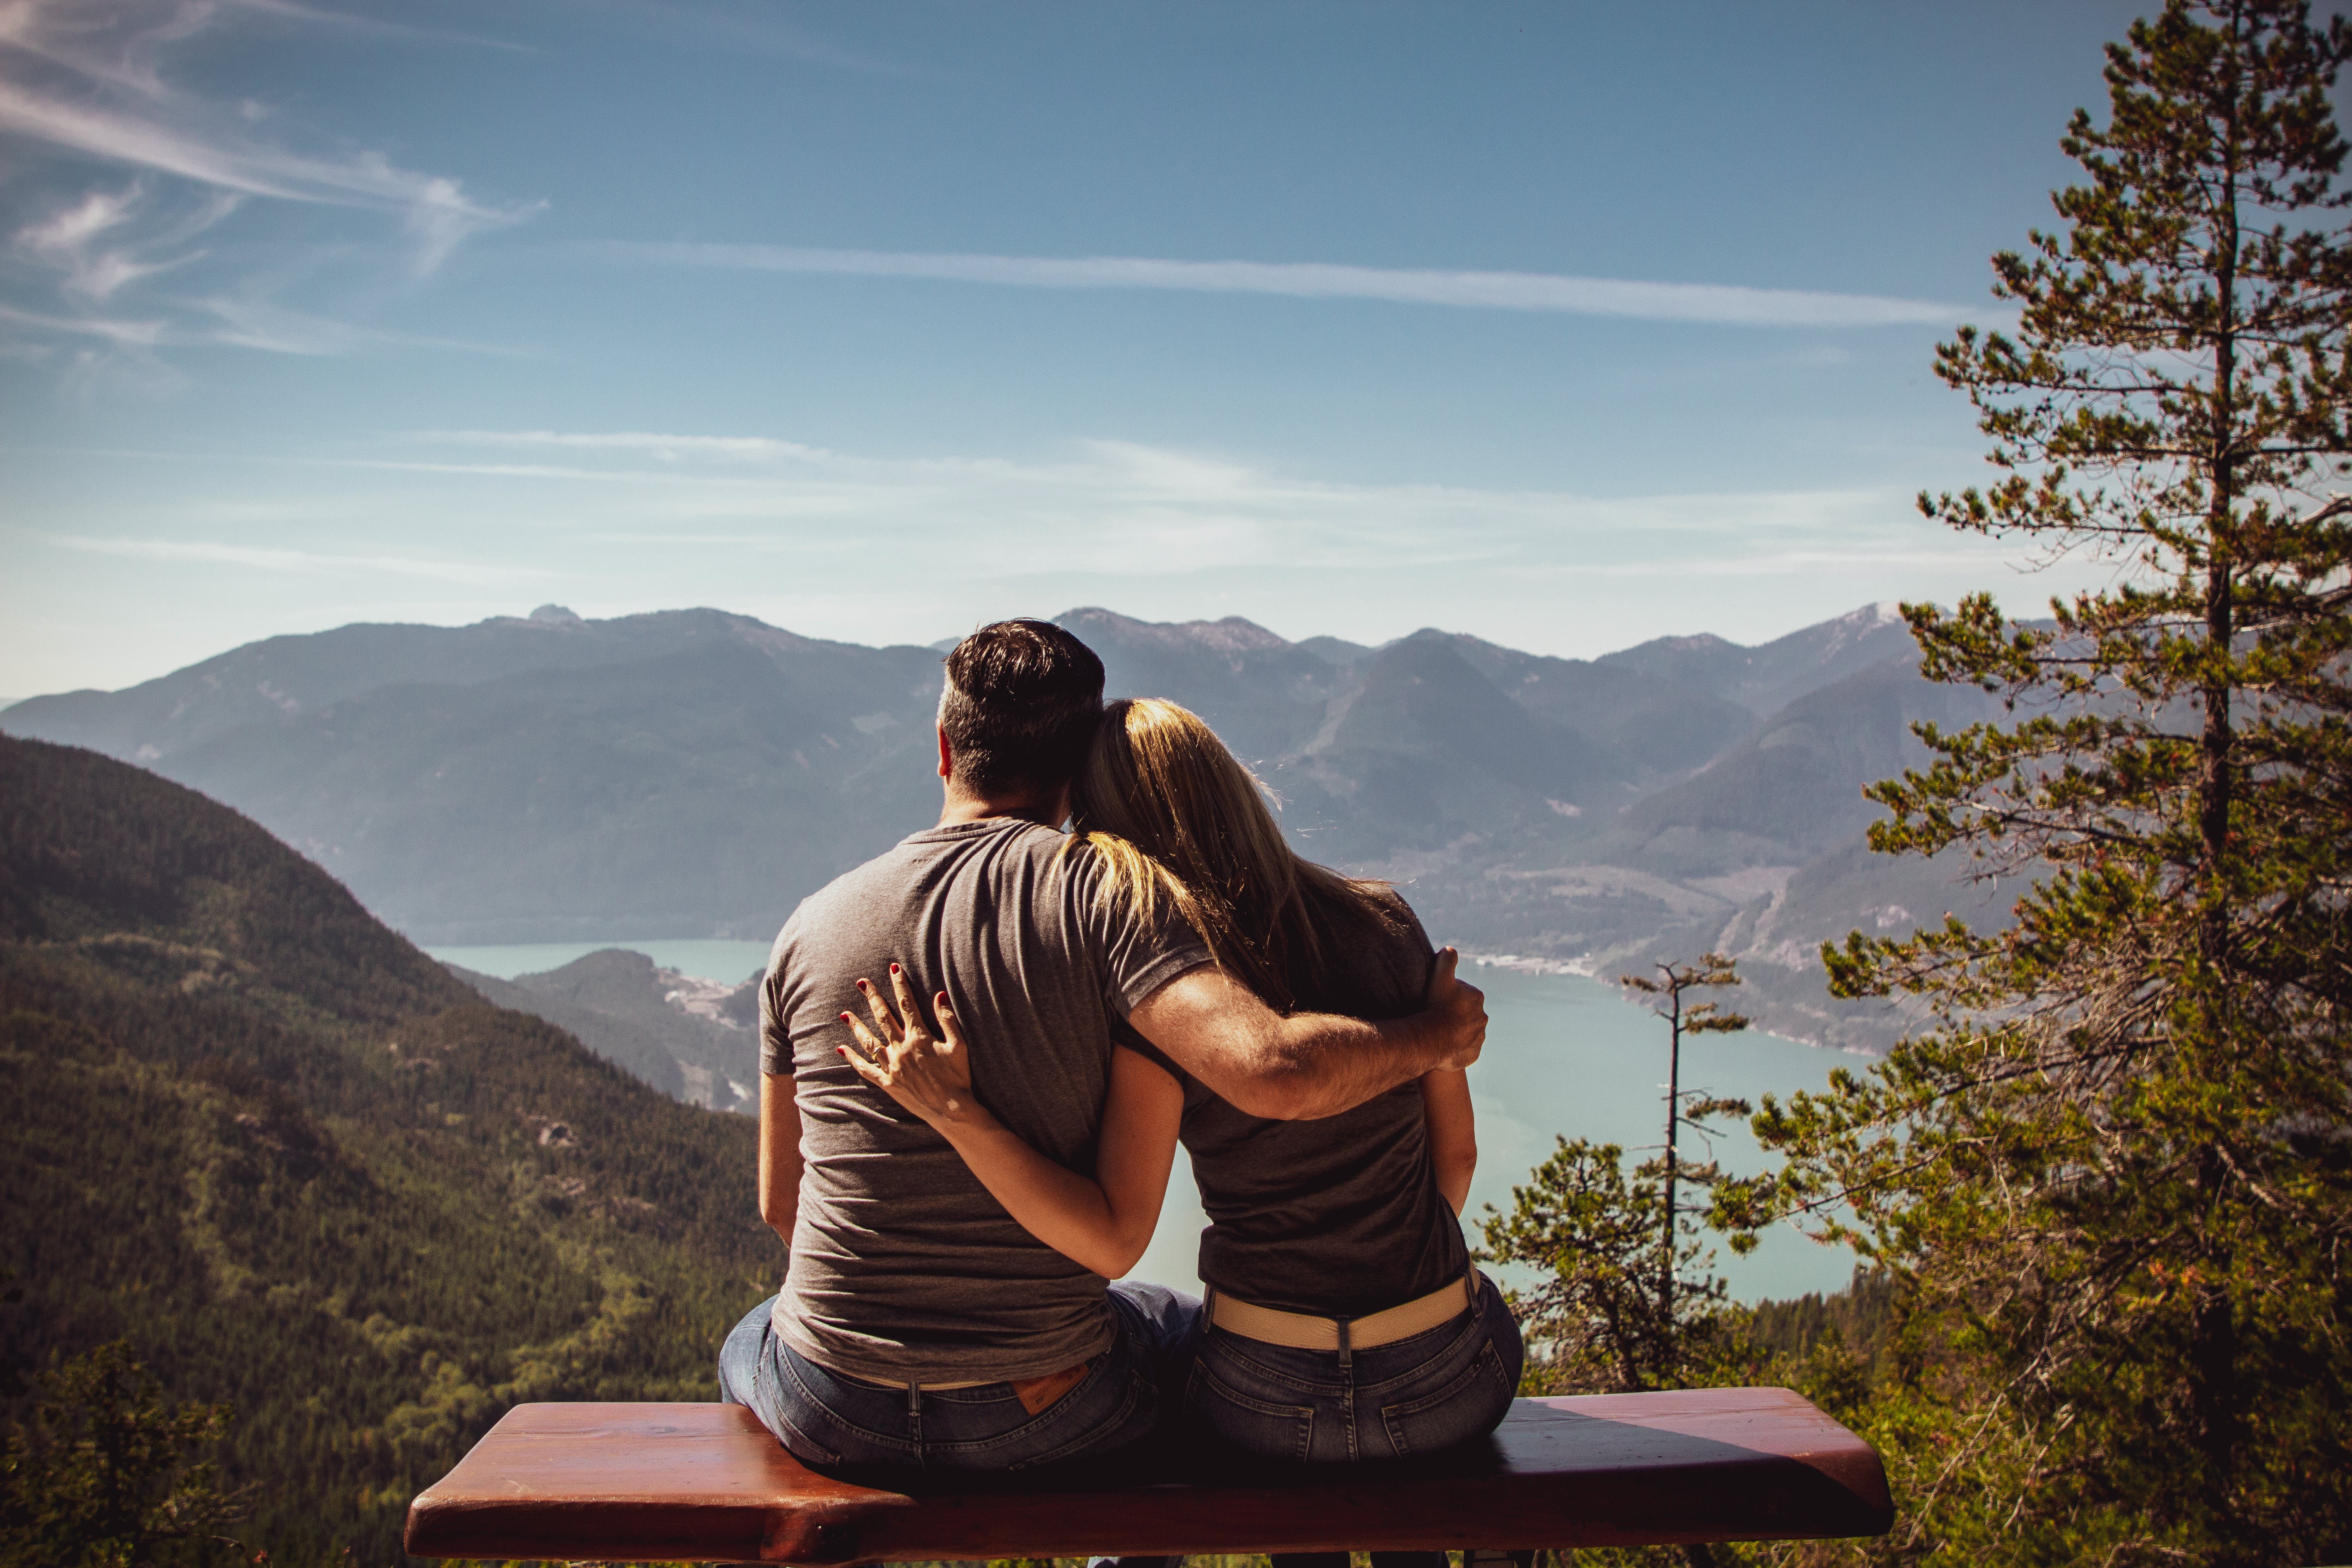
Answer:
[{"left": 428, "top": 938, "right": 1865, "bottom": 1300}]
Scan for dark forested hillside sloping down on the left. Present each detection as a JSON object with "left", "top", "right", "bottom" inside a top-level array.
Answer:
[{"left": 0, "top": 741, "right": 781, "bottom": 1561}]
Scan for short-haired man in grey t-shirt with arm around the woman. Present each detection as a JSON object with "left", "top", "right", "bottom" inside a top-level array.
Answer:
[{"left": 720, "top": 621, "right": 1486, "bottom": 1469}]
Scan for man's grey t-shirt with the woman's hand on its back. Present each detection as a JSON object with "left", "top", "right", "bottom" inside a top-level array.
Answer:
[{"left": 760, "top": 816, "right": 1209, "bottom": 1382}]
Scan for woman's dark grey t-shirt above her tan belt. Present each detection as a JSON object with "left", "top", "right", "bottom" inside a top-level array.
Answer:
[{"left": 1120, "top": 893, "right": 1470, "bottom": 1317}]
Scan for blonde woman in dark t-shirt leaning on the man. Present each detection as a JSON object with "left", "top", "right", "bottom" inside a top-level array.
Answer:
[{"left": 844, "top": 698, "right": 1522, "bottom": 1559}]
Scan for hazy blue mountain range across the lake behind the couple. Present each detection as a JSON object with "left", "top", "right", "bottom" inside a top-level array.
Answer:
[{"left": 0, "top": 606, "right": 1992, "bottom": 1053}]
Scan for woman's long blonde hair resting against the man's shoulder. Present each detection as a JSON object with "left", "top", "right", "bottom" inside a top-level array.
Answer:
[{"left": 1070, "top": 696, "right": 1400, "bottom": 1011}]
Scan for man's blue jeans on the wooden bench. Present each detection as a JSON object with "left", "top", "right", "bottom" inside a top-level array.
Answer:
[{"left": 720, "top": 1281, "right": 1200, "bottom": 1472}]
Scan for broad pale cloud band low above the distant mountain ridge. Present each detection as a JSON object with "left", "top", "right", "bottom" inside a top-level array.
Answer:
[{"left": 341, "top": 430, "right": 1917, "bottom": 578}]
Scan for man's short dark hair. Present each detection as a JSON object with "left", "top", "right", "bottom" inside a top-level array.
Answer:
[{"left": 938, "top": 621, "right": 1103, "bottom": 797}]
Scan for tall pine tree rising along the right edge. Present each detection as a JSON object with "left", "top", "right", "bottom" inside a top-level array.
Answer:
[{"left": 1726, "top": 0, "right": 2352, "bottom": 1563}]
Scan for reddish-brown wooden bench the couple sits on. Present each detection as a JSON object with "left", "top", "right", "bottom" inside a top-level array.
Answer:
[{"left": 407, "top": 1389, "right": 1893, "bottom": 1568}]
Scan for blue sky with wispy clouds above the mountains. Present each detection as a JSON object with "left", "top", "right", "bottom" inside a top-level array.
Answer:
[{"left": 0, "top": 0, "right": 2183, "bottom": 698}]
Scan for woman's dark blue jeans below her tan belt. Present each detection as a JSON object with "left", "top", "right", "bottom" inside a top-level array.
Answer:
[{"left": 1185, "top": 1277, "right": 1526, "bottom": 1464}]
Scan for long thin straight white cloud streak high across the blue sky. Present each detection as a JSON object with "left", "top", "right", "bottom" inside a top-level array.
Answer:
[{"left": 595, "top": 240, "right": 1983, "bottom": 327}]
